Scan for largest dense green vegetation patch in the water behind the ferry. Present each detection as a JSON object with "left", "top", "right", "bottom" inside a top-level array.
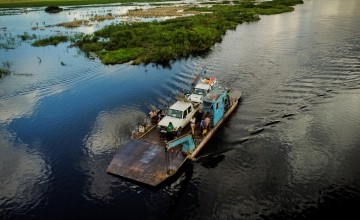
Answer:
[{"left": 76, "top": 0, "right": 303, "bottom": 64}]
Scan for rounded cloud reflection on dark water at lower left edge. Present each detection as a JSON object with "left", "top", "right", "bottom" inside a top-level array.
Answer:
[{"left": 0, "top": 127, "right": 50, "bottom": 212}]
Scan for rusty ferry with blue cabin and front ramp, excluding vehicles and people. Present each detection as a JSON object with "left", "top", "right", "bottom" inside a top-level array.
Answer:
[{"left": 107, "top": 68, "right": 242, "bottom": 186}]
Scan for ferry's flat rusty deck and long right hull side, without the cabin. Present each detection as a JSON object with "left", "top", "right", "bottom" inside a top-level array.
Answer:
[{"left": 107, "top": 90, "right": 241, "bottom": 186}]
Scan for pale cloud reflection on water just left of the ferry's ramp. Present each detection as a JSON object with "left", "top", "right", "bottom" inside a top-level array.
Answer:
[{"left": 80, "top": 108, "right": 146, "bottom": 201}]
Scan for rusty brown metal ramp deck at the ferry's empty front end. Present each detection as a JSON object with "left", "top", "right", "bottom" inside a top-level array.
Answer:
[{"left": 107, "top": 129, "right": 186, "bottom": 186}]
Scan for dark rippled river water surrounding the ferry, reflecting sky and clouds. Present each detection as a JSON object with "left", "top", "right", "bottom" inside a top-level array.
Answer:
[{"left": 0, "top": 0, "right": 360, "bottom": 219}]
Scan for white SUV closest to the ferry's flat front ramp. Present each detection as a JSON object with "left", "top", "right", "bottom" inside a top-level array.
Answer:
[{"left": 158, "top": 101, "right": 196, "bottom": 135}]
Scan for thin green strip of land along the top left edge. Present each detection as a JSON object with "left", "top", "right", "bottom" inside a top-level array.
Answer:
[{"left": 0, "top": 0, "right": 165, "bottom": 8}]
